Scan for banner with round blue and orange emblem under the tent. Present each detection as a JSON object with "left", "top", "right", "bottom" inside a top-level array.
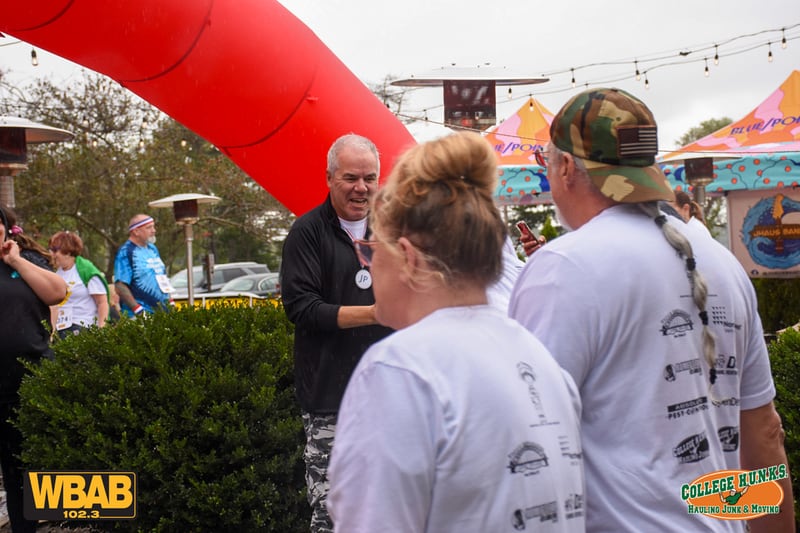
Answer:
[{"left": 727, "top": 188, "right": 800, "bottom": 278}]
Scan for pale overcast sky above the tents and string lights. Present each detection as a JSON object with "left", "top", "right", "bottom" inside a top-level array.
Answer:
[{"left": 0, "top": 0, "right": 800, "bottom": 150}]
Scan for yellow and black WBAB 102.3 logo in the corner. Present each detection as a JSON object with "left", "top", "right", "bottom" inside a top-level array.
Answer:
[{"left": 23, "top": 471, "right": 136, "bottom": 520}]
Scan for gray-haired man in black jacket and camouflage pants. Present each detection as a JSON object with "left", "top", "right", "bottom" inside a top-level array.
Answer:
[{"left": 281, "top": 134, "right": 391, "bottom": 533}]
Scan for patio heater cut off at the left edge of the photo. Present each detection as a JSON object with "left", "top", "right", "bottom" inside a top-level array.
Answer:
[{"left": 0, "top": 116, "right": 73, "bottom": 208}]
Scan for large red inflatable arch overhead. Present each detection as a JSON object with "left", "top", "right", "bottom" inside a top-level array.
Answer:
[{"left": 0, "top": 0, "right": 414, "bottom": 215}]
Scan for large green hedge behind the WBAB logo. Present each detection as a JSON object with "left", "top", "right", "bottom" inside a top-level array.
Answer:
[{"left": 18, "top": 306, "right": 310, "bottom": 533}]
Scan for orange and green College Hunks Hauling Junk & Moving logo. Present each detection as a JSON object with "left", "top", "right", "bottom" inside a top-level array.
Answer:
[{"left": 681, "top": 465, "right": 788, "bottom": 520}]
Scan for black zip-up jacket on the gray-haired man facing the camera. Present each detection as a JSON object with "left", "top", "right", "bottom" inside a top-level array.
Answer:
[{"left": 280, "top": 195, "right": 392, "bottom": 414}]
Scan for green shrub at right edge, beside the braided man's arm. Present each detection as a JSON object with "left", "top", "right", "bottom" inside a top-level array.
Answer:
[{"left": 769, "top": 329, "right": 800, "bottom": 531}]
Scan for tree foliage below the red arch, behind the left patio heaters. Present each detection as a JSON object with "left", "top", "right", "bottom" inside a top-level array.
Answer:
[{"left": 0, "top": 74, "right": 292, "bottom": 278}]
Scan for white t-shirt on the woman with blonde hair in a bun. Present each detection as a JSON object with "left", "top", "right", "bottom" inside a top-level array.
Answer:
[{"left": 328, "top": 305, "right": 584, "bottom": 533}]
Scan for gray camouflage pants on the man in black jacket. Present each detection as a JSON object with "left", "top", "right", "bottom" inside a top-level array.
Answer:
[{"left": 303, "top": 412, "right": 336, "bottom": 533}]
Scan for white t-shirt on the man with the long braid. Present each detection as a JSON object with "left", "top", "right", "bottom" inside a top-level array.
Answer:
[{"left": 509, "top": 202, "right": 775, "bottom": 532}]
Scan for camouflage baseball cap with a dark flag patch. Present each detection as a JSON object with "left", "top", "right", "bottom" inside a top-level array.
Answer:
[{"left": 550, "top": 89, "right": 675, "bottom": 203}]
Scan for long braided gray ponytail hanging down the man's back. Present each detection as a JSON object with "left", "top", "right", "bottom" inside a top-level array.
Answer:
[{"left": 637, "top": 202, "right": 719, "bottom": 404}]
